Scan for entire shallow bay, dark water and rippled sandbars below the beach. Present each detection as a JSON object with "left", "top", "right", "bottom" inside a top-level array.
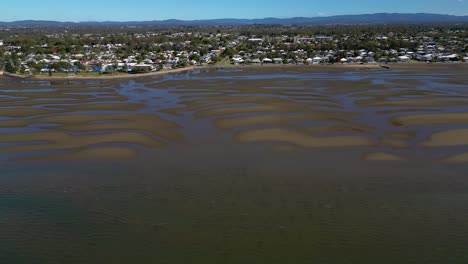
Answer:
[{"left": 0, "top": 66, "right": 468, "bottom": 263}]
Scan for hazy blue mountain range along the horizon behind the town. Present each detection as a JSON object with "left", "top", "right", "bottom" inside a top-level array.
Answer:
[{"left": 0, "top": 13, "right": 468, "bottom": 26}]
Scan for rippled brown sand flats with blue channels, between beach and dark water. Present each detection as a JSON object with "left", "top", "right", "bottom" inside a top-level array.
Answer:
[{"left": 0, "top": 65, "right": 468, "bottom": 160}]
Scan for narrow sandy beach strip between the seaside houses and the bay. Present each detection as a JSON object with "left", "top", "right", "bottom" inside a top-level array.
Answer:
[{"left": 0, "top": 62, "right": 468, "bottom": 81}]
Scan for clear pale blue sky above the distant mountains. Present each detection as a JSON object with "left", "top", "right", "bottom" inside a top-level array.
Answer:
[{"left": 0, "top": 0, "right": 468, "bottom": 22}]
